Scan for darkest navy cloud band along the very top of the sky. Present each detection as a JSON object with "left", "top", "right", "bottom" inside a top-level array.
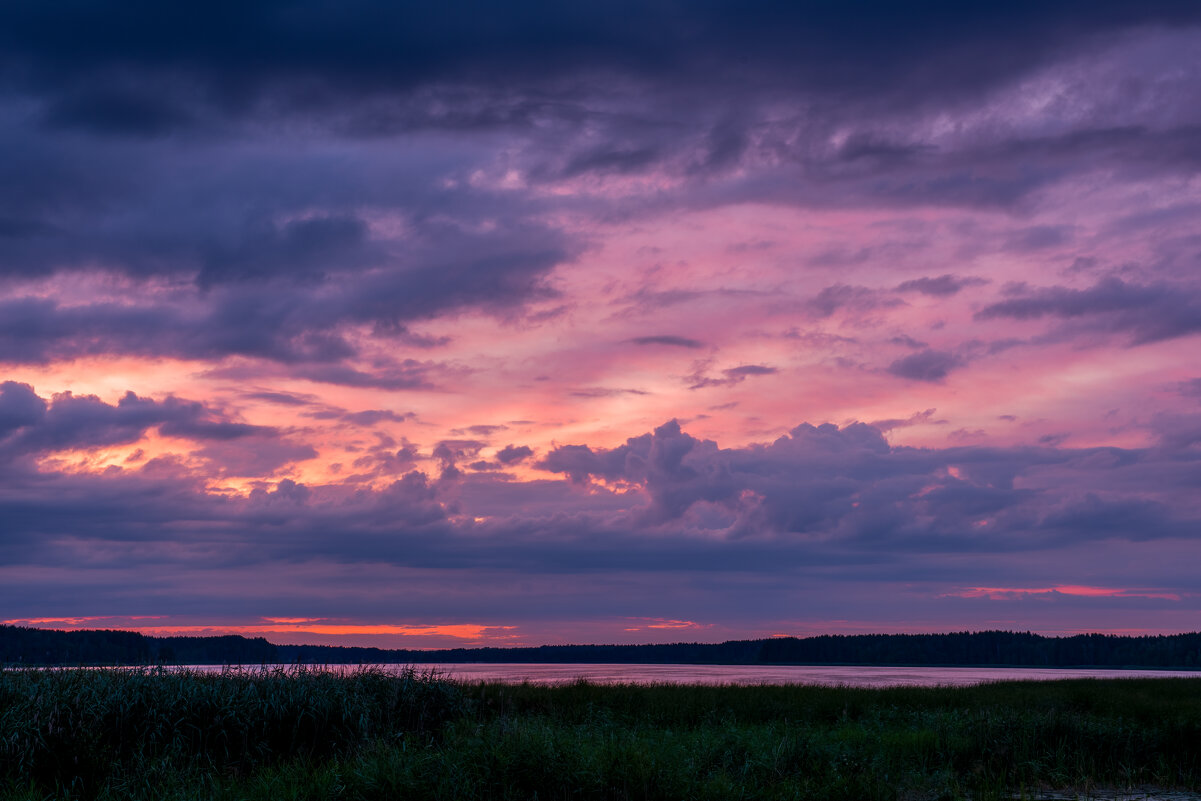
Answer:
[{"left": 0, "top": 0, "right": 1201, "bottom": 122}]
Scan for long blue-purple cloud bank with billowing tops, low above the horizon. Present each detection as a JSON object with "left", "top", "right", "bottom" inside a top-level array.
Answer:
[{"left": 0, "top": 413, "right": 1201, "bottom": 618}]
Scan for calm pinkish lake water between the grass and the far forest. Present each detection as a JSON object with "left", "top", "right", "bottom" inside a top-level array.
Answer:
[{"left": 341, "top": 663, "right": 1201, "bottom": 687}]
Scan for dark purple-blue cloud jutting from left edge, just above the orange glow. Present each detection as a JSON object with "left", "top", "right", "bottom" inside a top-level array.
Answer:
[{"left": 0, "top": 221, "right": 569, "bottom": 369}]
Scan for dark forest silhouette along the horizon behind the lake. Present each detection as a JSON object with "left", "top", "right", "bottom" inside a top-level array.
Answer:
[{"left": 0, "top": 626, "right": 1201, "bottom": 669}]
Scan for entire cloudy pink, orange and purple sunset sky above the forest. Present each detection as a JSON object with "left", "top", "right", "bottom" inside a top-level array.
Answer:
[{"left": 0, "top": 0, "right": 1201, "bottom": 648}]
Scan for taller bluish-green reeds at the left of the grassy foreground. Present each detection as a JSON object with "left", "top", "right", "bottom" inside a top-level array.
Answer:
[{"left": 0, "top": 668, "right": 462, "bottom": 799}]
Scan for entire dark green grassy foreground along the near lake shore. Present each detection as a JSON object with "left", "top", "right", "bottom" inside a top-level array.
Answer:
[{"left": 0, "top": 670, "right": 1201, "bottom": 801}]
